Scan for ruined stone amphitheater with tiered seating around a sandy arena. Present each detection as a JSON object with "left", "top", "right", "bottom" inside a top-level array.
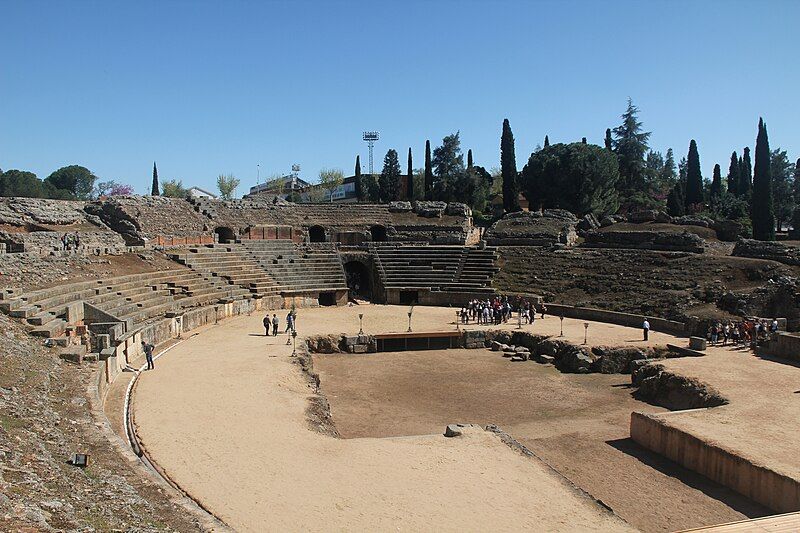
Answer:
[{"left": 0, "top": 197, "right": 800, "bottom": 531}]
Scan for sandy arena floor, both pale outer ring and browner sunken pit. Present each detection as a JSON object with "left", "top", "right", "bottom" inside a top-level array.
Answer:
[{"left": 133, "top": 305, "right": 780, "bottom": 531}]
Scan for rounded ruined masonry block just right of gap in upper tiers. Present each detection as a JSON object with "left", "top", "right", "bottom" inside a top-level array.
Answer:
[{"left": 486, "top": 209, "right": 578, "bottom": 246}]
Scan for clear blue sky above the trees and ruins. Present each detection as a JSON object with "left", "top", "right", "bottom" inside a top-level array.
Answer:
[{"left": 0, "top": 0, "right": 800, "bottom": 194}]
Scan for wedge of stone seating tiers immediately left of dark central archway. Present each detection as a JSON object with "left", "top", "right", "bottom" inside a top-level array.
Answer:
[{"left": 242, "top": 239, "right": 347, "bottom": 293}]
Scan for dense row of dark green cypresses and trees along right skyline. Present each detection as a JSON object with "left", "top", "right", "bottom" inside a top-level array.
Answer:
[{"left": 355, "top": 99, "right": 800, "bottom": 240}]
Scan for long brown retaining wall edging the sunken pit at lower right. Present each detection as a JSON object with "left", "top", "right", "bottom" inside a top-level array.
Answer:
[{"left": 631, "top": 411, "right": 800, "bottom": 512}]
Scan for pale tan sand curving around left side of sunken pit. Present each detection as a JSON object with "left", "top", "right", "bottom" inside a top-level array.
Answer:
[{"left": 134, "top": 306, "right": 629, "bottom": 531}]
